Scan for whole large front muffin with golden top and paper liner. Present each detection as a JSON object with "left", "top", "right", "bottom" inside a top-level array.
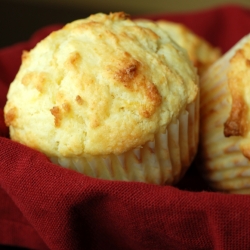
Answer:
[{"left": 4, "top": 12, "right": 199, "bottom": 185}]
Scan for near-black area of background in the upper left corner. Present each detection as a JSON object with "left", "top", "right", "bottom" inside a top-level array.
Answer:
[{"left": 0, "top": 0, "right": 92, "bottom": 48}]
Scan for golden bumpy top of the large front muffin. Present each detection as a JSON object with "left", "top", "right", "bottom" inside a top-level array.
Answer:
[{"left": 4, "top": 12, "right": 198, "bottom": 157}]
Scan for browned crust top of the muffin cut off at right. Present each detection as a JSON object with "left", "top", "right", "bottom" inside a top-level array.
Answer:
[{"left": 224, "top": 39, "right": 250, "bottom": 159}]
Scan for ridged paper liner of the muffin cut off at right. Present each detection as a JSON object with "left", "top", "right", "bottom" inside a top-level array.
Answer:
[{"left": 200, "top": 33, "right": 250, "bottom": 194}]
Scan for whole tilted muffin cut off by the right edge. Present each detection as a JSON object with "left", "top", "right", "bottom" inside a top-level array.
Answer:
[{"left": 200, "top": 35, "right": 250, "bottom": 193}]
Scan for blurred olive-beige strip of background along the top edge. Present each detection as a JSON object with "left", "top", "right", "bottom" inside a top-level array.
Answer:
[{"left": 10, "top": 0, "right": 250, "bottom": 14}]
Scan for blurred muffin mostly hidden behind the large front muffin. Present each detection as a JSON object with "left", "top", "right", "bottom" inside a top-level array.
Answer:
[{"left": 136, "top": 19, "right": 221, "bottom": 74}]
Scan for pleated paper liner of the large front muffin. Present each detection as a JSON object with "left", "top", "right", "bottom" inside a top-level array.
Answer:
[{"left": 50, "top": 92, "right": 199, "bottom": 185}]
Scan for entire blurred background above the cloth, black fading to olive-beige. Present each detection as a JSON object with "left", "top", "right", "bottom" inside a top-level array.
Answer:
[{"left": 0, "top": 0, "right": 250, "bottom": 48}]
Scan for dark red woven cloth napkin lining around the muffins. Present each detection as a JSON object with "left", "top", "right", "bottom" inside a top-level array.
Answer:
[{"left": 0, "top": 6, "right": 250, "bottom": 250}]
